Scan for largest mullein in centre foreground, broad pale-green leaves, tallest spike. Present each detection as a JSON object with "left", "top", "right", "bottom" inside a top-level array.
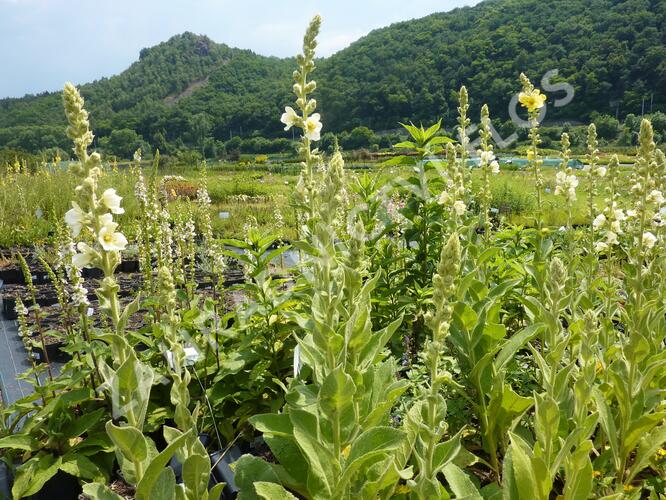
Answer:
[{"left": 231, "top": 17, "right": 410, "bottom": 499}]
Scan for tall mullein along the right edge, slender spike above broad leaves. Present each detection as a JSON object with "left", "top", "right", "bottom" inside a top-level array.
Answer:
[{"left": 593, "top": 120, "right": 666, "bottom": 494}]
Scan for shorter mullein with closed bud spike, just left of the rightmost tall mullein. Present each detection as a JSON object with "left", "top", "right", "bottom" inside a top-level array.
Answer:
[{"left": 503, "top": 257, "right": 598, "bottom": 500}]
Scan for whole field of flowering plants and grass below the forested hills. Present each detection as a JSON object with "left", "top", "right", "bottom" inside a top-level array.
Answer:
[{"left": 0, "top": 17, "right": 666, "bottom": 500}]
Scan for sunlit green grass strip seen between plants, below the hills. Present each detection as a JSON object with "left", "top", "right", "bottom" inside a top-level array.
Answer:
[{"left": 0, "top": 157, "right": 631, "bottom": 247}]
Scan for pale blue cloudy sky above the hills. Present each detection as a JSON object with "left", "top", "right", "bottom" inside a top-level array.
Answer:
[{"left": 0, "top": 0, "right": 478, "bottom": 98}]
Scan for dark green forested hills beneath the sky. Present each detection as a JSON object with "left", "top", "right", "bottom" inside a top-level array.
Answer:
[{"left": 0, "top": 0, "right": 666, "bottom": 155}]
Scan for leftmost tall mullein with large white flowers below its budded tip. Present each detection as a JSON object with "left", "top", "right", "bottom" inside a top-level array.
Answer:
[{"left": 63, "top": 84, "right": 171, "bottom": 492}]
